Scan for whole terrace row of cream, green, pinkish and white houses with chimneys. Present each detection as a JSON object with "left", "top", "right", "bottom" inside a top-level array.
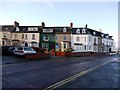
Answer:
[{"left": 0, "top": 21, "right": 114, "bottom": 52}]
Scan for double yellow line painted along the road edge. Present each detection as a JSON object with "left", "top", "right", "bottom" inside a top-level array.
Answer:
[{"left": 43, "top": 59, "right": 116, "bottom": 90}]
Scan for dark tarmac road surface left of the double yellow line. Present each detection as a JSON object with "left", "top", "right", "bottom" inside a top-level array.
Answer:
[{"left": 1, "top": 55, "right": 118, "bottom": 89}]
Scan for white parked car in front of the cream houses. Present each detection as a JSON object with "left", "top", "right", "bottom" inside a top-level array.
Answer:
[{"left": 15, "top": 47, "right": 37, "bottom": 55}]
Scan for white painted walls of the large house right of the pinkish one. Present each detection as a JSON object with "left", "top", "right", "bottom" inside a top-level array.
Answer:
[{"left": 71, "top": 34, "right": 98, "bottom": 52}]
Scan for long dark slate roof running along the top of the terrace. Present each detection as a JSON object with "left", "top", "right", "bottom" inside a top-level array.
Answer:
[{"left": 0, "top": 25, "right": 113, "bottom": 40}]
